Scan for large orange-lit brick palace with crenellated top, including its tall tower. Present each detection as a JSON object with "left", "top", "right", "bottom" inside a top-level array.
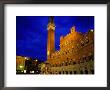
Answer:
[{"left": 41, "top": 18, "right": 94, "bottom": 74}]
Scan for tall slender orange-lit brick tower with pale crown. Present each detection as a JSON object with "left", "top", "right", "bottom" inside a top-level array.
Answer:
[{"left": 47, "top": 16, "right": 55, "bottom": 60}]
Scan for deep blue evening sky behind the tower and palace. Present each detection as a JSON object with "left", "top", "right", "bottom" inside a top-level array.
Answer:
[{"left": 16, "top": 16, "right": 94, "bottom": 61}]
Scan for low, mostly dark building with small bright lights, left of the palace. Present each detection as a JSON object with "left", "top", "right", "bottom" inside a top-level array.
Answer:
[{"left": 16, "top": 56, "right": 41, "bottom": 74}]
